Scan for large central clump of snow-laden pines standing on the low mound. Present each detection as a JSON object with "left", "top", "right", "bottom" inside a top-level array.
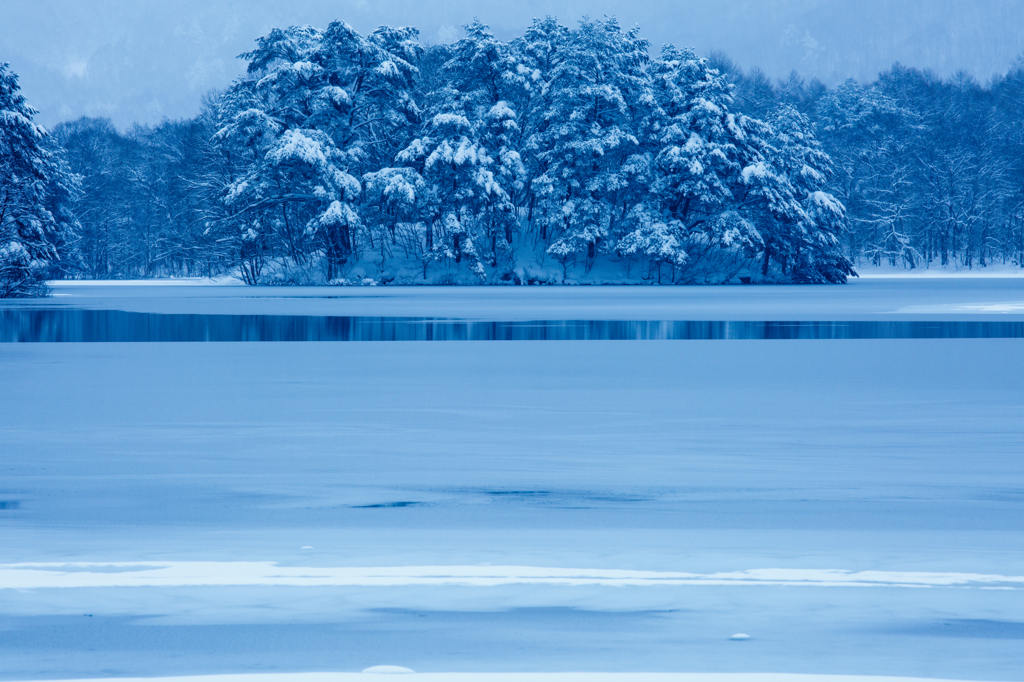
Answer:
[{"left": 205, "top": 18, "right": 852, "bottom": 282}]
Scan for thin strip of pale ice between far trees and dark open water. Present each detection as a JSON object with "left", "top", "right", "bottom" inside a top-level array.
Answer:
[{"left": 14, "top": 276, "right": 1024, "bottom": 321}]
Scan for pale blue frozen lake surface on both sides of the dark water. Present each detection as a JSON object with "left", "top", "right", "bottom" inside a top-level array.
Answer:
[{"left": 0, "top": 278, "right": 1024, "bottom": 682}]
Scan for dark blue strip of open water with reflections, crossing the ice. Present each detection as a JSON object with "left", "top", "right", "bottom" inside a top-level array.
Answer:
[{"left": 0, "top": 309, "right": 1024, "bottom": 343}]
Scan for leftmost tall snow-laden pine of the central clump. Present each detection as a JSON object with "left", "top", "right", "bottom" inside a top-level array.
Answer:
[{"left": 218, "top": 22, "right": 422, "bottom": 280}]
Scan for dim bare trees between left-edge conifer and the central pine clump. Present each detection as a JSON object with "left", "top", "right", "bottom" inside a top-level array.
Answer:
[{"left": 50, "top": 116, "right": 230, "bottom": 279}]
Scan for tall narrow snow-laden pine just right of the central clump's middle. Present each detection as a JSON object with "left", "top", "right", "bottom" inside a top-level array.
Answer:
[{"left": 526, "top": 18, "right": 652, "bottom": 268}]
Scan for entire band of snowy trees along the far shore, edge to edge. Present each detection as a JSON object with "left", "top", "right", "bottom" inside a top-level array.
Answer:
[{"left": 0, "top": 18, "right": 1024, "bottom": 296}]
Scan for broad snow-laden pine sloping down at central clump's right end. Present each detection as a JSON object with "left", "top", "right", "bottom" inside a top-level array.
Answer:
[{"left": 638, "top": 46, "right": 851, "bottom": 282}]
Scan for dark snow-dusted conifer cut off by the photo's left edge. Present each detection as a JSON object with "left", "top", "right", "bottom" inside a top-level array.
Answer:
[{"left": 0, "top": 63, "right": 79, "bottom": 298}]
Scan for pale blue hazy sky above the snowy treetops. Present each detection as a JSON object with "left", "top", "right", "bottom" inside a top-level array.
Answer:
[{"left": 0, "top": 0, "right": 1024, "bottom": 129}]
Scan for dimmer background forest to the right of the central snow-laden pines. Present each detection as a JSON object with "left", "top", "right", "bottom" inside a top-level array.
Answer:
[{"left": 711, "top": 55, "right": 1024, "bottom": 268}]
